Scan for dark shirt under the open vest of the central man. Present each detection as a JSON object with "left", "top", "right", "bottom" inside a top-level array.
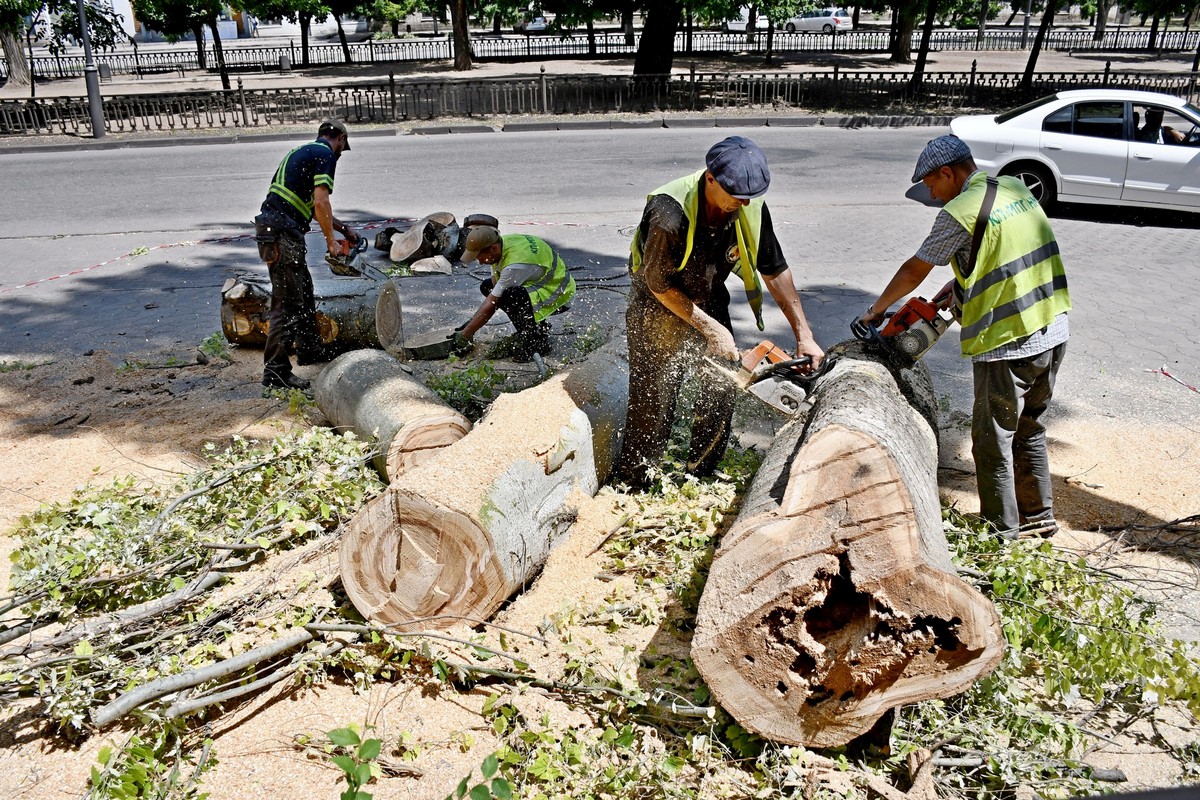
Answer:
[{"left": 634, "top": 187, "right": 787, "bottom": 312}]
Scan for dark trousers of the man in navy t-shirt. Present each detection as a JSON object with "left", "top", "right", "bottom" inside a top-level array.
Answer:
[{"left": 254, "top": 222, "right": 322, "bottom": 377}]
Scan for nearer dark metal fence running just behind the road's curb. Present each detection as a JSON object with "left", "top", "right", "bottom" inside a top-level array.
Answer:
[{"left": 0, "top": 67, "right": 1198, "bottom": 136}]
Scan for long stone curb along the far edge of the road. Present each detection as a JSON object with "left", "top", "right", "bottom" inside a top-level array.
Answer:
[{"left": 0, "top": 114, "right": 954, "bottom": 157}]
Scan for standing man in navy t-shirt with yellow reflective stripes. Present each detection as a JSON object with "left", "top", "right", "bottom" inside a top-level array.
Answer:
[{"left": 254, "top": 120, "right": 359, "bottom": 389}]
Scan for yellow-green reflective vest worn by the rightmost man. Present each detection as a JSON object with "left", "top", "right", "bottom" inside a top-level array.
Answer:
[{"left": 946, "top": 172, "right": 1070, "bottom": 356}]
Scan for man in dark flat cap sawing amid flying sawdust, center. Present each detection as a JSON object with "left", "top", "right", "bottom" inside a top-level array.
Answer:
[{"left": 617, "top": 136, "right": 824, "bottom": 487}]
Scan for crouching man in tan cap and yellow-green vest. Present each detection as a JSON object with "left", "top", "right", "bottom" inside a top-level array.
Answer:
[{"left": 451, "top": 225, "right": 575, "bottom": 362}]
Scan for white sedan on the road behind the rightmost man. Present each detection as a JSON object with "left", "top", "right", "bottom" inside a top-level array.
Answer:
[{"left": 950, "top": 89, "right": 1200, "bottom": 211}]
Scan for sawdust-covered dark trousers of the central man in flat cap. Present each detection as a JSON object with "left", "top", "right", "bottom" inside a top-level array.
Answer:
[{"left": 617, "top": 283, "right": 737, "bottom": 487}]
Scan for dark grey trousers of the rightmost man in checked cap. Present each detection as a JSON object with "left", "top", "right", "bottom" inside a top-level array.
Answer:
[{"left": 971, "top": 342, "right": 1067, "bottom": 530}]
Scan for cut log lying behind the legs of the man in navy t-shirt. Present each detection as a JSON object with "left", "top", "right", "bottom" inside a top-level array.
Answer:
[{"left": 221, "top": 275, "right": 403, "bottom": 356}]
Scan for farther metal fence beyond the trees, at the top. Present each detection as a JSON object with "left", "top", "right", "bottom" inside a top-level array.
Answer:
[{"left": 7, "top": 29, "right": 1200, "bottom": 78}]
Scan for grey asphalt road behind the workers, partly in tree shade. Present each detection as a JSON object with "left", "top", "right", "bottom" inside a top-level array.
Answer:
[{"left": 0, "top": 127, "right": 1200, "bottom": 429}]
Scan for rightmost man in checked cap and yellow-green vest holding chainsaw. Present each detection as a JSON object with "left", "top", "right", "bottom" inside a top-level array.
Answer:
[{"left": 859, "top": 136, "right": 1070, "bottom": 537}]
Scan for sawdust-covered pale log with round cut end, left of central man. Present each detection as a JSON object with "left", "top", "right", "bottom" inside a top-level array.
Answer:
[{"left": 341, "top": 341, "right": 629, "bottom": 630}]
